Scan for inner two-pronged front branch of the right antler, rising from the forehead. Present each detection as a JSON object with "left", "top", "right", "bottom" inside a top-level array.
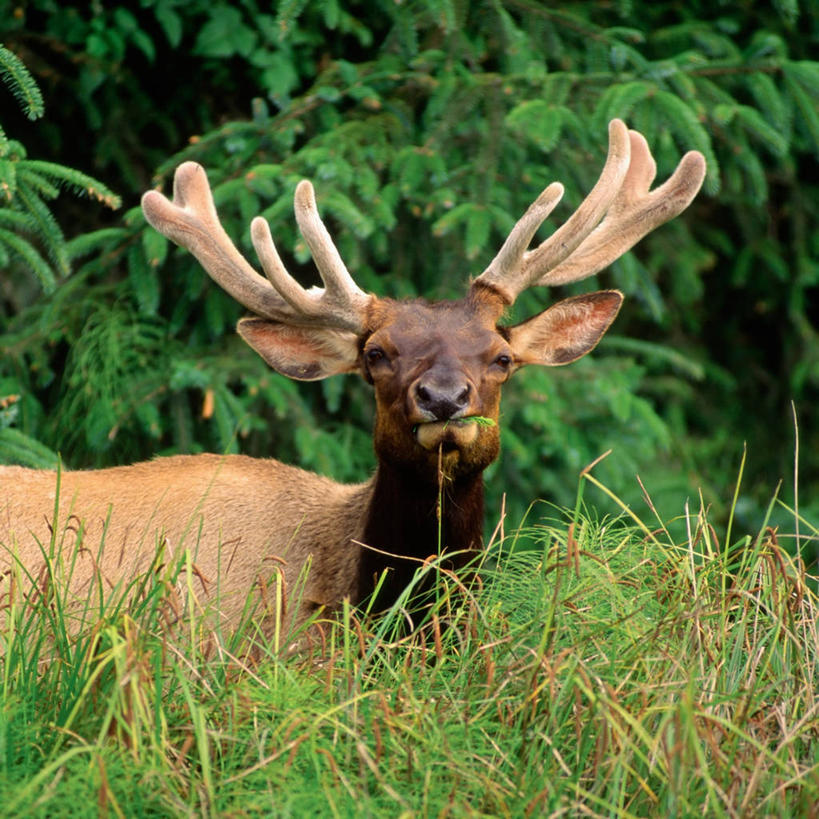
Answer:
[{"left": 476, "top": 119, "right": 631, "bottom": 304}]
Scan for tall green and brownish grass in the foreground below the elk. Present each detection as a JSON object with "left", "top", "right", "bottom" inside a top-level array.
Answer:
[{"left": 0, "top": 478, "right": 819, "bottom": 817}]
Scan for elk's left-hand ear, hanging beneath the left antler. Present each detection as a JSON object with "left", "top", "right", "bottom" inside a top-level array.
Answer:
[{"left": 236, "top": 318, "right": 358, "bottom": 381}]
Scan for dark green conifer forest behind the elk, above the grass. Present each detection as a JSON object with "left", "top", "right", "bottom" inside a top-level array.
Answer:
[{"left": 0, "top": 0, "right": 819, "bottom": 556}]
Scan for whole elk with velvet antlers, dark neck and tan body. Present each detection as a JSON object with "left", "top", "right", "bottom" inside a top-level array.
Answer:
[{"left": 0, "top": 120, "right": 705, "bottom": 629}]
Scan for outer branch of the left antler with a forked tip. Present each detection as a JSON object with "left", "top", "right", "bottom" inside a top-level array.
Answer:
[{"left": 142, "top": 162, "right": 291, "bottom": 319}]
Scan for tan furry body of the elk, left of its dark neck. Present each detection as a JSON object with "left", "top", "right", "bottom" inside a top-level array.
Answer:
[{"left": 0, "top": 455, "right": 371, "bottom": 631}]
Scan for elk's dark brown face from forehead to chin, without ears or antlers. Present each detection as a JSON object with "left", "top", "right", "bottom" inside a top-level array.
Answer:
[{"left": 360, "top": 297, "right": 514, "bottom": 479}]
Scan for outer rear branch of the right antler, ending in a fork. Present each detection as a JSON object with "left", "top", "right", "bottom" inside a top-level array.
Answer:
[{"left": 536, "top": 131, "right": 706, "bottom": 285}]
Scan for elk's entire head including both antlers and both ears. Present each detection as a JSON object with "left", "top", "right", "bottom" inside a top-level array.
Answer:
[{"left": 142, "top": 120, "right": 705, "bottom": 481}]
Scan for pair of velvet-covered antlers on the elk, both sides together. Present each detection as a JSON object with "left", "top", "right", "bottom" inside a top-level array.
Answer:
[{"left": 142, "top": 119, "right": 705, "bottom": 333}]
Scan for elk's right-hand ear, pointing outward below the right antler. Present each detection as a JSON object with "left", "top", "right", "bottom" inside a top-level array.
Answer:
[{"left": 507, "top": 290, "right": 623, "bottom": 366}]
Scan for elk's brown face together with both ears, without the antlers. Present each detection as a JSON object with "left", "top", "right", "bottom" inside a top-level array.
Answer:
[{"left": 239, "top": 283, "right": 623, "bottom": 481}]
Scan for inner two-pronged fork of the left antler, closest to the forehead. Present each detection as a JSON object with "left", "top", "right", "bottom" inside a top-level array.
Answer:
[{"left": 250, "top": 180, "right": 372, "bottom": 333}]
